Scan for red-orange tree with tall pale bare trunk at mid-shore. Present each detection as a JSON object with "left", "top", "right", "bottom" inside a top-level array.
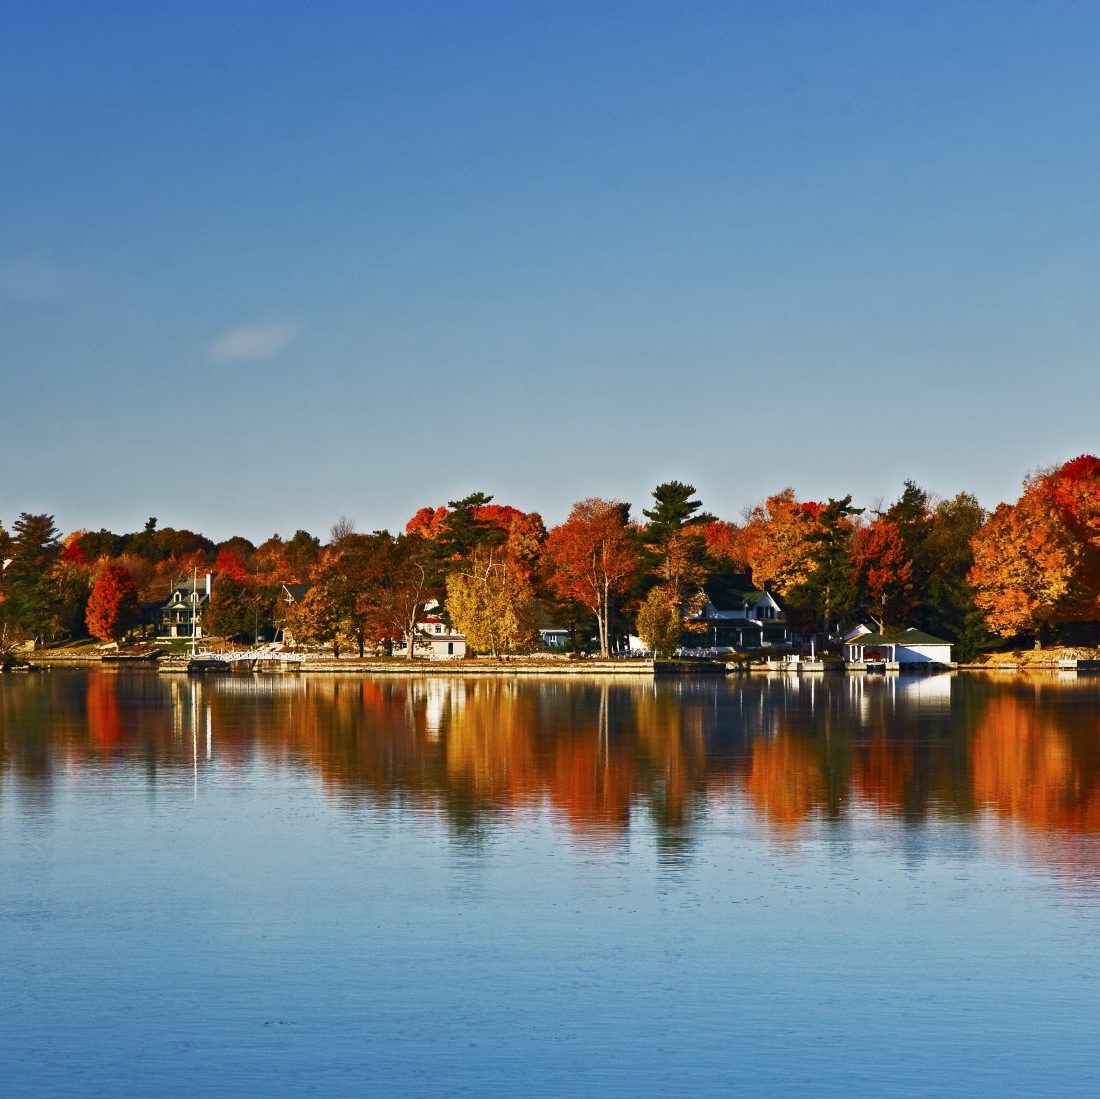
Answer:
[{"left": 547, "top": 497, "right": 640, "bottom": 657}]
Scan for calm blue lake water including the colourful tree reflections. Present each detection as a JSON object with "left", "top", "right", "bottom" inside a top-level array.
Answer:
[{"left": 0, "top": 671, "right": 1100, "bottom": 1097}]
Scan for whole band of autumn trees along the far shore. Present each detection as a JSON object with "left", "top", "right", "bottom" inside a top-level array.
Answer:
[{"left": 0, "top": 455, "right": 1100, "bottom": 659}]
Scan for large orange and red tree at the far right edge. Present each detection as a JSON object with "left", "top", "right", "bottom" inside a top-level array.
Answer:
[{"left": 969, "top": 455, "right": 1100, "bottom": 638}]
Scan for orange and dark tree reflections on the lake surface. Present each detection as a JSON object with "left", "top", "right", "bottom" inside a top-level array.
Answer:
[{"left": 0, "top": 672, "right": 1100, "bottom": 872}]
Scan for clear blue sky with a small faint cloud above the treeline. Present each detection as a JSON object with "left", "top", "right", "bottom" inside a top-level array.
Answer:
[{"left": 0, "top": 0, "right": 1100, "bottom": 539}]
